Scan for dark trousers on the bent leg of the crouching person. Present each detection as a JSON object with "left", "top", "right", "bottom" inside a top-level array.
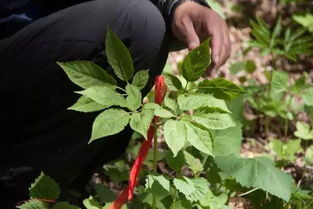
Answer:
[{"left": 0, "top": 0, "right": 168, "bottom": 206}]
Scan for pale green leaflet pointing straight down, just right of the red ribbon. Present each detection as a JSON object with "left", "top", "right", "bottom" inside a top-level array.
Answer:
[{"left": 163, "top": 120, "right": 187, "bottom": 157}]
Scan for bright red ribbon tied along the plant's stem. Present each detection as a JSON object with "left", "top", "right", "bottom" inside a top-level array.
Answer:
[{"left": 109, "top": 76, "right": 167, "bottom": 209}]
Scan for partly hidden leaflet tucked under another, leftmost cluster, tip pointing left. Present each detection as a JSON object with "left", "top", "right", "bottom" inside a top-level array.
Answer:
[{"left": 68, "top": 96, "right": 107, "bottom": 113}]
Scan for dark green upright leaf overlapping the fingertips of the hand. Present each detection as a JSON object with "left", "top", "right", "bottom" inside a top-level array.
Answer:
[{"left": 182, "top": 40, "right": 211, "bottom": 82}]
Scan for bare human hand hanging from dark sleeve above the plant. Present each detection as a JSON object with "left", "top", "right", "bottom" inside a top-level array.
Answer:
[{"left": 172, "top": 1, "right": 231, "bottom": 72}]
